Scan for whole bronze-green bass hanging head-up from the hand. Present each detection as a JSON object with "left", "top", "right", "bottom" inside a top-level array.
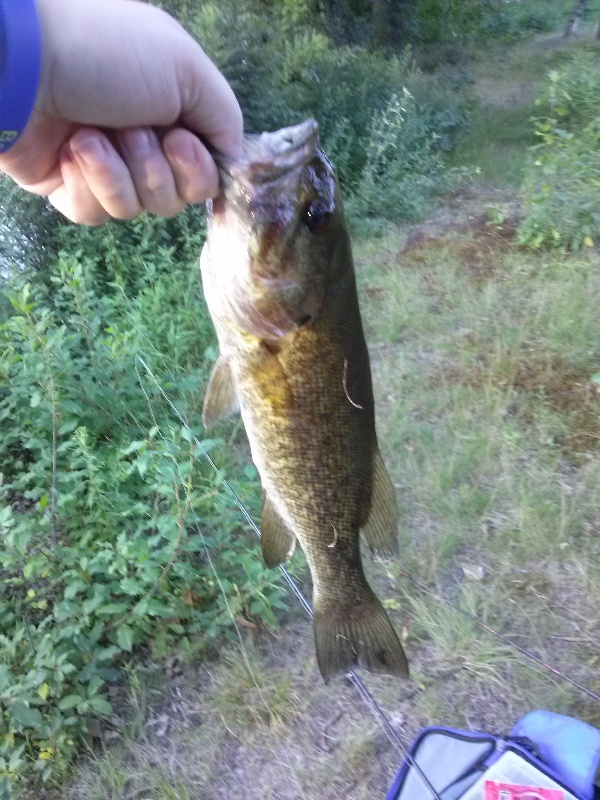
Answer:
[{"left": 200, "top": 119, "right": 408, "bottom": 682}]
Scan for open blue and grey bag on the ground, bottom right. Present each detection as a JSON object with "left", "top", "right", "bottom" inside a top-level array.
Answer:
[{"left": 387, "top": 711, "right": 600, "bottom": 800}]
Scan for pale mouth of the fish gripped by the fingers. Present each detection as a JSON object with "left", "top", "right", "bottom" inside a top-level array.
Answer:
[{"left": 213, "top": 119, "right": 319, "bottom": 188}]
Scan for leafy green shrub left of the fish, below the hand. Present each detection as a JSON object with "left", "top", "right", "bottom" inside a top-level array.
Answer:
[{"left": 0, "top": 228, "right": 283, "bottom": 796}]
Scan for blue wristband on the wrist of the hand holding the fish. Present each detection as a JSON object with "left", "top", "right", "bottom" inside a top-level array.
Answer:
[{"left": 0, "top": 0, "right": 42, "bottom": 153}]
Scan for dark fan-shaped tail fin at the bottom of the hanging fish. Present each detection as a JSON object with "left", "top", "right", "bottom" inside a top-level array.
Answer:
[{"left": 315, "top": 594, "right": 408, "bottom": 683}]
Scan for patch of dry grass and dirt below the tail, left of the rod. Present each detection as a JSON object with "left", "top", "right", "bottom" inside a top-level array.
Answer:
[{"left": 54, "top": 620, "right": 414, "bottom": 800}]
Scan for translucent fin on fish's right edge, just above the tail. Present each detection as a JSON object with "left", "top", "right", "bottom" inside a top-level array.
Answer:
[{"left": 362, "top": 447, "right": 398, "bottom": 558}]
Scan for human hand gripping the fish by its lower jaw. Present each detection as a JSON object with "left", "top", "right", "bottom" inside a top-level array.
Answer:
[{"left": 0, "top": 0, "right": 242, "bottom": 225}]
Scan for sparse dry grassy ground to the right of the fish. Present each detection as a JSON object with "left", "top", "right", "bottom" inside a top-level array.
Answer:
[{"left": 361, "top": 184, "right": 600, "bottom": 730}]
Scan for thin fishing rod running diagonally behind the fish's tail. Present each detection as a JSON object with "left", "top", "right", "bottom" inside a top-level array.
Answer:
[{"left": 135, "top": 353, "right": 446, "bottom": 800}]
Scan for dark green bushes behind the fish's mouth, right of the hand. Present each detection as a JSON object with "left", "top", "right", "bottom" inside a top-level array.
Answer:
[{"left": 190, "top": 0, "right": 468, "bottom": 219}]
